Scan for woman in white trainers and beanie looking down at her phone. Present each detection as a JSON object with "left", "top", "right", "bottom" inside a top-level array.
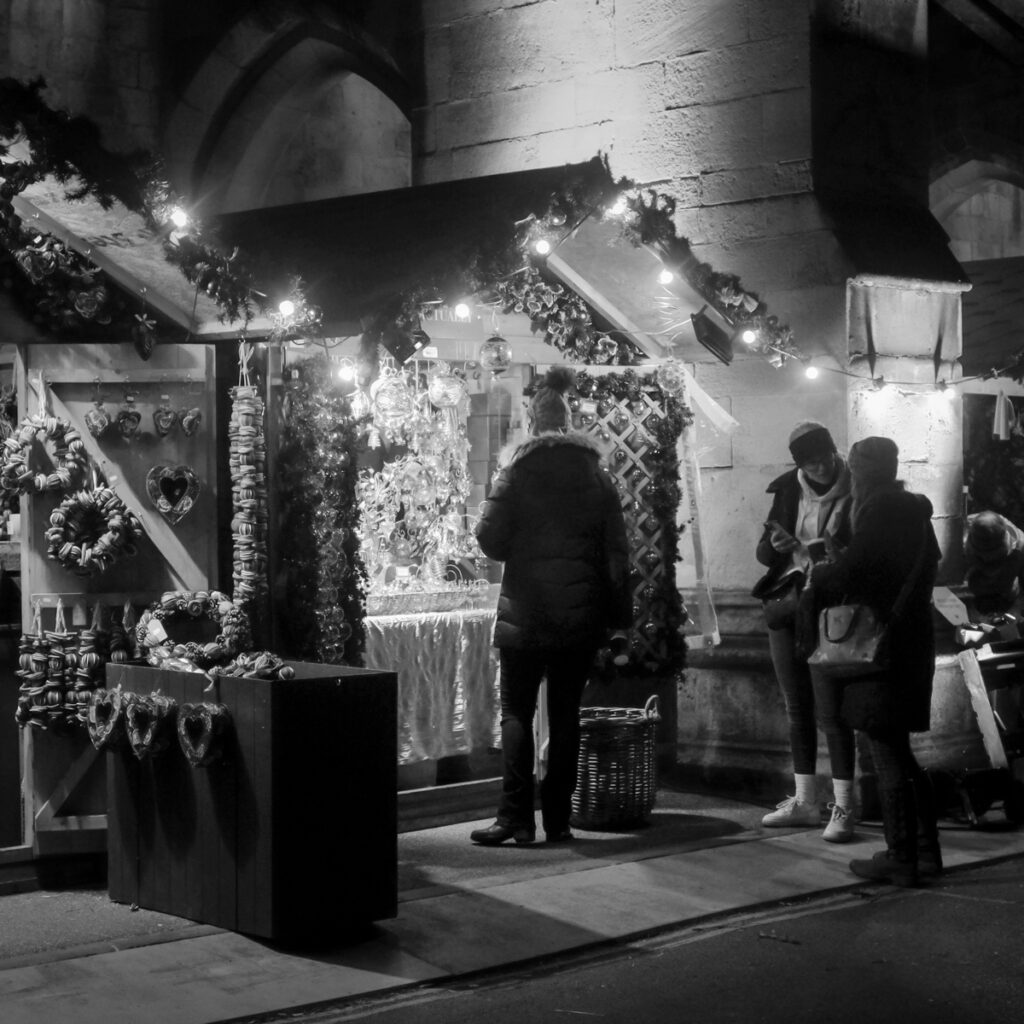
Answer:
[{"left": 753, "top": 420, "right": 855, "bottom": 843}]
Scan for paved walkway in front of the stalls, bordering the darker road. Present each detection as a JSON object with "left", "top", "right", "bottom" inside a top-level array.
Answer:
[{"left": 0, "top": 787, "right": 1024, "bottom": 1024}]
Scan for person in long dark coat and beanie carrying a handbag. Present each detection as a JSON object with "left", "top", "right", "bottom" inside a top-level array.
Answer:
[{"left": 811, "top": 437, "right": 942, "bottom": 886}]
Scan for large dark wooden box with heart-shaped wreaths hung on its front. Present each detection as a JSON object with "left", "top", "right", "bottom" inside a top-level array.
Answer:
[{"left": 106, "top": 662, "right": 397, "bottom": 942}]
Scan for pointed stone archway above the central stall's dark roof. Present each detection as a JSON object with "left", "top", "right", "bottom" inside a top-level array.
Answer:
[{"left": 163, "top": 4, "right": 412, "bottom": 216}]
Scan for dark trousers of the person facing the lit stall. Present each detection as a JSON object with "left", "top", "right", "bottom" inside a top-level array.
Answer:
[{"left": 498, "top": 647, "right": 596, "bottom": 831}]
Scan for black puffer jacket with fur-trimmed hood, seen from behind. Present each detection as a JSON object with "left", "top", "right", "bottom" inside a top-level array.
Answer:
[{"left": 476, "top": 433, "right": 632, "bottom": 649}]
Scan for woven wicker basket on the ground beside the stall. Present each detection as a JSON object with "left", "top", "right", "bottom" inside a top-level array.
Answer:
[{"left": 572, "top": 695, "right": 662, "bottom": 831}]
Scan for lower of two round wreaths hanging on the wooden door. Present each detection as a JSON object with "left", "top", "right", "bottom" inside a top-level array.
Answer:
[{"left": 46, "top": 487, "right": 142, "bottom": 575}]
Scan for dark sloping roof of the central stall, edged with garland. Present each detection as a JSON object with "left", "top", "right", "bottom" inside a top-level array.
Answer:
[{"left": 212, "top": 158, "right": 608, "bottom": 334}]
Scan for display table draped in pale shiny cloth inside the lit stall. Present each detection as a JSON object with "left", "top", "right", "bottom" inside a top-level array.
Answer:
[{"left": 366, "top": 608, "right": 499, "bottom": 764}]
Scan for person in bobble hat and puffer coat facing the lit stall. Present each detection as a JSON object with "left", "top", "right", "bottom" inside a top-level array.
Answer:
[{"left": 470, "top": 367, "right": 632, "bottom": 846}]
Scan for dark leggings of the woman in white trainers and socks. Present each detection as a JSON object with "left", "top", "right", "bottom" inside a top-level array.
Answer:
[{"left": 768, "top": 627, "right": 855, "bottom": 779}]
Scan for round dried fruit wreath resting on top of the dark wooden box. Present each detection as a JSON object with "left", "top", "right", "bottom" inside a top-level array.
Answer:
[{"left": 135, "top": 590, "right": 250, "bottom": 669}]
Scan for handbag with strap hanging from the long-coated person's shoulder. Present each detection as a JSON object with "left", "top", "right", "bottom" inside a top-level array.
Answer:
[{"left": 807, "top": 536, "right": 928, "bottom": 679}]
